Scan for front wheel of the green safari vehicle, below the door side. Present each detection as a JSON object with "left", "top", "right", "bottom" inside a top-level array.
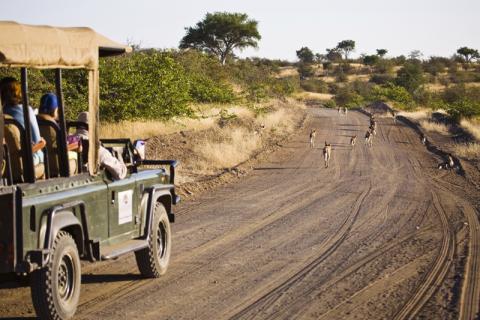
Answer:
[{"left": 135, "top": 202, "right": 172, "bottom": 278}]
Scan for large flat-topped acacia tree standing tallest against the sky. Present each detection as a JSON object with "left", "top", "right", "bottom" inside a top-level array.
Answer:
[{"left": 180, "top": 12, "right": 261, "bottom": 64}]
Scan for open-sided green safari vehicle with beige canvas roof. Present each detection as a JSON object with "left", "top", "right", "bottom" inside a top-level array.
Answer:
[{"left": 0, "top": 22, "right": 179, "bottom": 319}]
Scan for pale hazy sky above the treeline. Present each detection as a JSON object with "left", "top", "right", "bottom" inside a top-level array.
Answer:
[{"left": 0, "top": 0, "right": 480, "bottom": 61}]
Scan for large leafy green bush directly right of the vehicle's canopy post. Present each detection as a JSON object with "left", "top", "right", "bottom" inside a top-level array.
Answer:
[{"left": 100, "top": 51, "right": 192, "bottom": 121}]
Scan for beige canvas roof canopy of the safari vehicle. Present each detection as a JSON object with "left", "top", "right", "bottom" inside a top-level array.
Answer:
[{"left": 0, "top": 21, "right": 131, "bottom": 70}]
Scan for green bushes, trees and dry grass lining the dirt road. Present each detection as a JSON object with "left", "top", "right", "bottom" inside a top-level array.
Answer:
[{"left": 0, "top": 12, "right": 480, "bottom": 166}]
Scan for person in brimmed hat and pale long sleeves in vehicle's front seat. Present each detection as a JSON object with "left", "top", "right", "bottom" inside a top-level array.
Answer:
[{"left": 75, "top": 112, "right": 127, "bottom": 180}]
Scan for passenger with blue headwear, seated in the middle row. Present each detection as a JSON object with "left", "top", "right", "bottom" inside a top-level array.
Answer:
[{"left": 38, "top": 93, "right": 79, "bottom": 177}]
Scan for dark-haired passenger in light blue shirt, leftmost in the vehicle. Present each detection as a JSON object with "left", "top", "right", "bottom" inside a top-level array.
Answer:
[{"left": 0, "top": 78, "right": 45, "bottom": 179}]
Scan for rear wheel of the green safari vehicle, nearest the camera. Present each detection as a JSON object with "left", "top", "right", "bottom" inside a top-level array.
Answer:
[{"left": 30, "top": 231, "right": 81, "bottom": 320}]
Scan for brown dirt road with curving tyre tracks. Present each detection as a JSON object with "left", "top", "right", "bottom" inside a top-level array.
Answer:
[{"left": 0, "top": 109, "right": 480, "bottom": 320}]
